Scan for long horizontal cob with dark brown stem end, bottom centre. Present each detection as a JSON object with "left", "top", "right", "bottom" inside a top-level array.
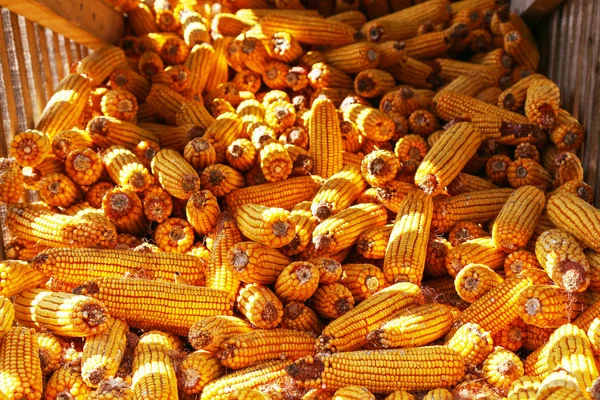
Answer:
[{"left": 286, "top": 346, "right": 464, "bottom": 393}]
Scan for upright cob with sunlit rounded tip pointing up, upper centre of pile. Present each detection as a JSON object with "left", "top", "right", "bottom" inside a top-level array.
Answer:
[{"left": 308, "top": 98, "right": 342, "bottom": 178}]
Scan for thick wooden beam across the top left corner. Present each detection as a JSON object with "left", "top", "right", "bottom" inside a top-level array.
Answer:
[{"left": 0, "top": 0, "right": 125, "bottom": 49}]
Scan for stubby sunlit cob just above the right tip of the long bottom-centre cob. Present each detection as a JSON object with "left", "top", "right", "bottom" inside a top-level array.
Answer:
[{"left": 446, "top": 322, "right": 493, "bottom": 365}]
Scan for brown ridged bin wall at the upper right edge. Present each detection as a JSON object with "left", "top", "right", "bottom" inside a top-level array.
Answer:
[{"left": 534, "top": 0, "right": 600, "bottom": 206}]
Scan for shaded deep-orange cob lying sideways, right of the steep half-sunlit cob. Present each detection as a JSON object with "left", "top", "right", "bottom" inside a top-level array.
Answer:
[{"left": 432, "top": 189, "right": 513, "bottom": 233}]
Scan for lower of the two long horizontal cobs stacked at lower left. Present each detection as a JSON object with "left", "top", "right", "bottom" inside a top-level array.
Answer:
[{"left": 74, "top": 278, "right": 232, "bottom": 335}]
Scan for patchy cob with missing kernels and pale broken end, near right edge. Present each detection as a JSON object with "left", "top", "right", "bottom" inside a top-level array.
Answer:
[{"left": 535, "top": 230, "right": 590, "bottom": 292}]
